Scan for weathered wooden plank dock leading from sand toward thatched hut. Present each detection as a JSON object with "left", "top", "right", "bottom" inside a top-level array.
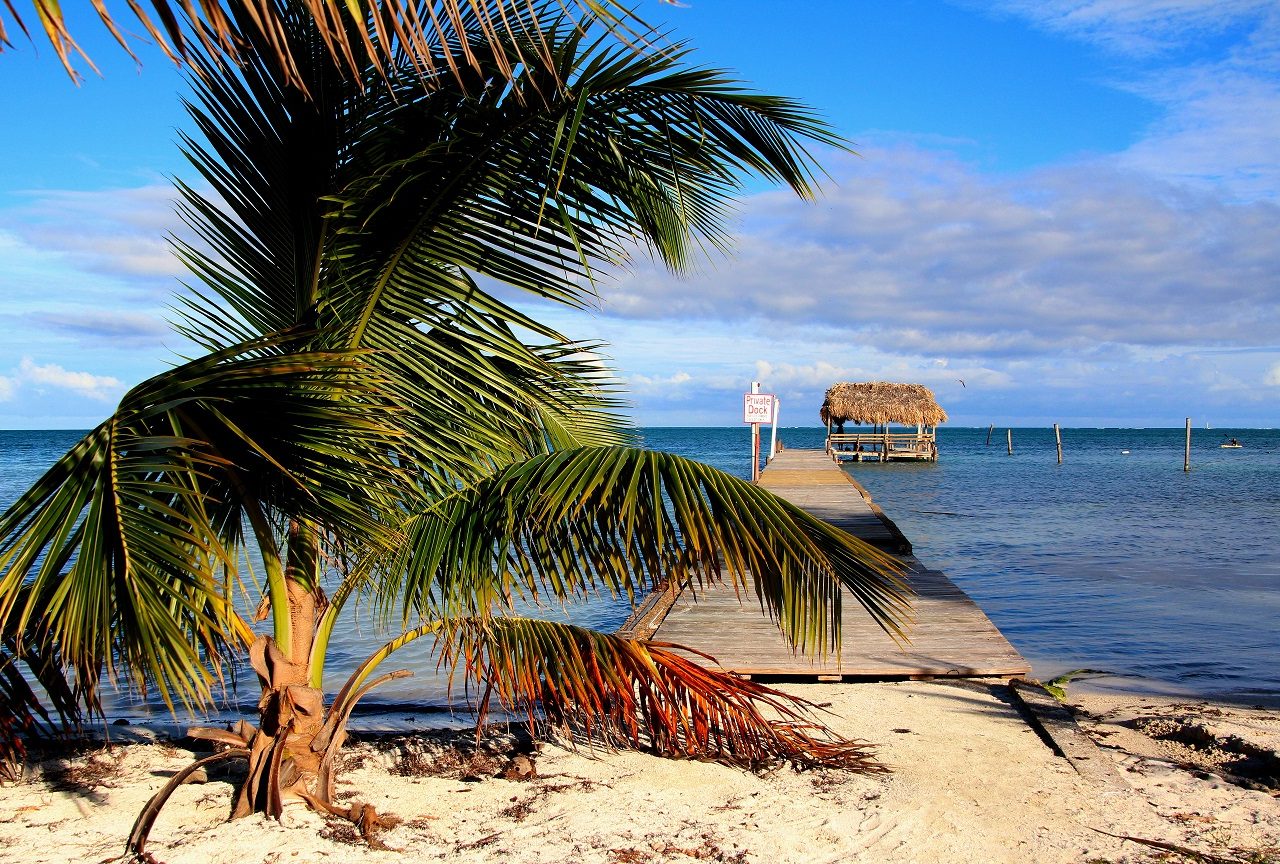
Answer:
[{"left": 621, "top": 451, "right": 1030, "bottom": 681}]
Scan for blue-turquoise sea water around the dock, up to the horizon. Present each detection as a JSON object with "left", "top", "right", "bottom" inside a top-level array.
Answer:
[{"left": 0, "top": 426, "right": 1280, "bottom": 726}]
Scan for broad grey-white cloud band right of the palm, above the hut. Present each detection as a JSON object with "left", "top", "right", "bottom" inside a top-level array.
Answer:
[{"left": 593, "top": 145, "right": 1280, "bottom": 358}]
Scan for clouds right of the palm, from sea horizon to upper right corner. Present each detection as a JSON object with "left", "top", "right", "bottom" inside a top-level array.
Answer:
[{"left": 591, "top": 0, "right": 1280, "bottom": 425}]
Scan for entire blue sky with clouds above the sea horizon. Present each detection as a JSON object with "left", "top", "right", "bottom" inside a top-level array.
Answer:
[{"left": 0, "top": 0, "right": 1280, "bottom": 429}]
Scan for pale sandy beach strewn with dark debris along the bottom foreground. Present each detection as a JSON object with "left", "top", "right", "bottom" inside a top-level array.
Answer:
[{"left": 0, "top": 682, "right": 1280, "bottom": 864}]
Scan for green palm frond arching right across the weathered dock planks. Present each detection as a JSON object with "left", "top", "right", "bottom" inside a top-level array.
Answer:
[{"left": 378, "top": 447, "right": 909, "bottom": 652}]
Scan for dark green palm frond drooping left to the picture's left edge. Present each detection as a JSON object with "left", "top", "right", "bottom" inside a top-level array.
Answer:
[{"left": 0, "top": 339, "right": 407, "bottom": 707}]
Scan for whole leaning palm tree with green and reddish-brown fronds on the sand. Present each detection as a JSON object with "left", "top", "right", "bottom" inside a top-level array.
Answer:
[{"left": 0, "top": 0, "right": 904, "bottom": 854}]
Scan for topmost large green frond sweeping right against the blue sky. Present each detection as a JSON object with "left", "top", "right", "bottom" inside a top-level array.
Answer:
[{"left": 340, "top": 16, "right": 844, "bottom": 311}]
